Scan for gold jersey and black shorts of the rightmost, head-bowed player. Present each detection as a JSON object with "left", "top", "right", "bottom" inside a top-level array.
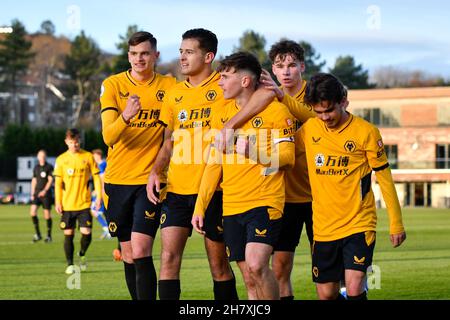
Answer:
[{"left": 300, "top": 114, "right": 404, "bottom": 283}]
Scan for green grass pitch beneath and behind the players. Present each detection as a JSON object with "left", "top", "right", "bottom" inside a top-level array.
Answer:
[{"left": 0, "top": 205, "right": 450, "bottom": 300}]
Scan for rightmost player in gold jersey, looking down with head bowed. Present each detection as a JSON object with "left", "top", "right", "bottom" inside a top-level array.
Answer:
[{"left": 300, "top": 73, "right": 406, "bottom": 300}]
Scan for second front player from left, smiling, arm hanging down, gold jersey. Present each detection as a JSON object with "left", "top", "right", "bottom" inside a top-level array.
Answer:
[{"left": 147, "top": 29, "right": 238, "bottom": 300}]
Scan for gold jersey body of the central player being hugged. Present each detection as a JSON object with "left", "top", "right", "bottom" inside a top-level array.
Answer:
[{"left": 218, "top": 101, "right": 294, "bottom": 219}]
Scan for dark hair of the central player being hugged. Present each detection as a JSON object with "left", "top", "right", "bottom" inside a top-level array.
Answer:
[{"left": 217, "top": 52, "right": 262, "bottom": 88}]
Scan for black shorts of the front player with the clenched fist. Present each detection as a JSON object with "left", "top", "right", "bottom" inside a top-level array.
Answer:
[{"left": 105, "top": 183, "right": 161, "bottom": 242}]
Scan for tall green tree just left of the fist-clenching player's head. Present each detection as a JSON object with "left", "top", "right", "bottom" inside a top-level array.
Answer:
[{"left": 64, "top": 31, "right": 101, "bottom": 126}]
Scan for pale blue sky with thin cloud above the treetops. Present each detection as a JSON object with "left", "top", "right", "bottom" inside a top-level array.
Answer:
[{"left": 0, "top": 0, "right": 450, "bottom": 79}]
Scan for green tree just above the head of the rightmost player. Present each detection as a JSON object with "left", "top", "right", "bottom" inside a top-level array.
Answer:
[{"left": 329, "top": 56, "right": 373, "bottom": 89}]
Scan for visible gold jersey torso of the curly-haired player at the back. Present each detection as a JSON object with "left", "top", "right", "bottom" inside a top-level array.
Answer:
[{"left": 285, "top": 81, "right": 314, "bottom": 203}]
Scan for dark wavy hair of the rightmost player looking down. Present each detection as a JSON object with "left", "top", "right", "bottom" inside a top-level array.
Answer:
[{"left": 304, "top": 73, "right": 347, "bottom": 105}]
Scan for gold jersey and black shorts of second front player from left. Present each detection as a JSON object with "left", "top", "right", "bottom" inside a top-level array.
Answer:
[{"left": 160, "top": 72, "right": 226, "bottom": 241}]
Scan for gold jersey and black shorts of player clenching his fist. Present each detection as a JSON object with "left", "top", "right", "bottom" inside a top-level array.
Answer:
[{"left": 100, "top": 71, "right": 176, "bottom": 242}]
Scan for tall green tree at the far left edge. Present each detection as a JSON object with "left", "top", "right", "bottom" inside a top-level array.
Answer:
[{"left": 0, "top": 20, "right": 34, "bottom": 122}]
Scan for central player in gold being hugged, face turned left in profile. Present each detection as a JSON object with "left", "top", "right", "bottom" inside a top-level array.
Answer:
[{"left": 192, "top": 52, "right": 295, "bottom": 300}]
